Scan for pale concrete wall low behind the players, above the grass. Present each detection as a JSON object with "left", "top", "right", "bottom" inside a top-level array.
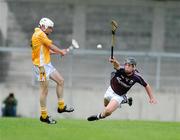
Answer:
[{"left": 0, "top": 85, "right": 180, "bottom": 121}]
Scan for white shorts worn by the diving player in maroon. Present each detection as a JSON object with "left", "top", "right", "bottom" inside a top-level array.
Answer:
[{"left": 104, "top": 86, "right": 127, "bottom": 107}]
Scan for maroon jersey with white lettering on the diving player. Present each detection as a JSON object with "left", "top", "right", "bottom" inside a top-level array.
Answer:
[{"left": 110, "top": 68, "right": 147, "bottom": 95}]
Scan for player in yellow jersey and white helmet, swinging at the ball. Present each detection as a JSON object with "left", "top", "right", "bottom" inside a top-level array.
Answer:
[{"left": 31, "top": 18, "right": 74, "bottom": 124}]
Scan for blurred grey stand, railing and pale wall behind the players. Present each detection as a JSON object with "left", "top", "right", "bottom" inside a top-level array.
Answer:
[{"left": 0, "top": 0, "right": 180, "bottom": 121}]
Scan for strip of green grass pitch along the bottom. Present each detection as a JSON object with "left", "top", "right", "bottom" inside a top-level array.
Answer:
[{"left": 0, "top": 118, "right": 180, "bottom": 140}]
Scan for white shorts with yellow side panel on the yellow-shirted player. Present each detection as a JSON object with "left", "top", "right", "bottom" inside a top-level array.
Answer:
[{"left": 33, "top": 63, "right": 56, "bottom": 81}]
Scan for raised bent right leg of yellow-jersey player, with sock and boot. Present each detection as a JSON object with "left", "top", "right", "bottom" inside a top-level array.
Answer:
[{"left": 50, "top": 70, "right": 74, "bottom": 113}]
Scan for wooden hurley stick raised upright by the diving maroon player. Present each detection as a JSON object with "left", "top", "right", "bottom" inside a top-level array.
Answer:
[{"left": 111, "top": 20, "right": 118, "bottom": 59}]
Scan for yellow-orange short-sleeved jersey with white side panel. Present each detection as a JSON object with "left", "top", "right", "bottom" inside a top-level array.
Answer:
[{"left": 31, "top": 28, "right": 52, "bottom": 66}]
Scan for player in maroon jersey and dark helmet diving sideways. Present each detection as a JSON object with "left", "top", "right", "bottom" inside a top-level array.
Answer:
[{"left": 87, "top": 58, "right": 157, "bottom": 121}]
